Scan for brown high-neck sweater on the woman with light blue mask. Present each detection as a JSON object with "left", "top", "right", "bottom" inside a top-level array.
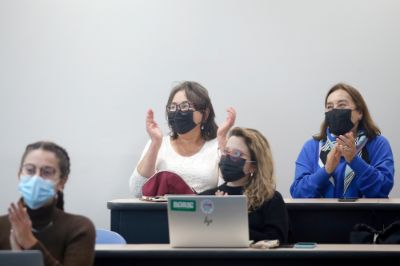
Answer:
[{"left": 0, "top": 204, "right": 96, "bottom": 266}]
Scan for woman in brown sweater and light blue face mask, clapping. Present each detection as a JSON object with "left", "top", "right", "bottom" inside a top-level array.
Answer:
[{"left": 0, "top": 141, "right": 95, "bottom": 266}]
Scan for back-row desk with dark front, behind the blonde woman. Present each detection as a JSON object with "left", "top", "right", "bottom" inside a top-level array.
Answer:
[{"left": 107, "top": 199, "right": 400, "bottom": 243}]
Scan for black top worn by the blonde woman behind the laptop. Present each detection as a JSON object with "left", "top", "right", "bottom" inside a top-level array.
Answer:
[{"left": 200, "top": 183, "right": 289, "bottom": 244}]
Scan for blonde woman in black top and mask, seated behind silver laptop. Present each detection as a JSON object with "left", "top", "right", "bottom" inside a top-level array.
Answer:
[{"left": 202, "top": 127, "right": 289, "bottom": 243}]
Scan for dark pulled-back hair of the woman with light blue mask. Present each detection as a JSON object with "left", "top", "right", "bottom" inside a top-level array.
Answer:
[{"left": 18, "top": 141, "right": 71, "bottom": 210}]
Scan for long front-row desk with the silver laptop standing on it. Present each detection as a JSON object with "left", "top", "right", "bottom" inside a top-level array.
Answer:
[{"left": 94, "top": 244, "right": 400, "bottom": 266}]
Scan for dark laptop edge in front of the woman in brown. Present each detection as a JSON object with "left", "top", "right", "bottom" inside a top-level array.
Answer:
[{"left": 0, "top": 250, "right": 44, "bottom": 266}]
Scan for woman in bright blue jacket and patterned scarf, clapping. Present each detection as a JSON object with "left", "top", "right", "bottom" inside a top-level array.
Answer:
[{"left": 290, "top": 83, "right": 394, "bottom": 198}]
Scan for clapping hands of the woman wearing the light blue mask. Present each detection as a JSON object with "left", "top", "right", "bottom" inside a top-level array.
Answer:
[{"left": 8, "top": 202, "right": 38, "bottom": 249}]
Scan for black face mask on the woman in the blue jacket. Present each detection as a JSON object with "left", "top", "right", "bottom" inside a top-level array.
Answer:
[{"left": 325, "top": 109, "right": 354, "bottom": 136}]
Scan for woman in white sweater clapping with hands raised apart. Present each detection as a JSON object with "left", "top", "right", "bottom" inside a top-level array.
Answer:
[{"left": 129, "top": 81, "right": 236, "bottom": 197}]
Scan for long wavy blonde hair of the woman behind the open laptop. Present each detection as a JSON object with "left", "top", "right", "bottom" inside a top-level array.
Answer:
[{"left": 229, "top": 127, "right": 276, "bottom": 210}]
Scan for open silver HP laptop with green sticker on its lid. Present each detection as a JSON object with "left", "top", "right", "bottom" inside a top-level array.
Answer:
[{"left": 167, "top": 195, "right": 250, "bottom": 247}]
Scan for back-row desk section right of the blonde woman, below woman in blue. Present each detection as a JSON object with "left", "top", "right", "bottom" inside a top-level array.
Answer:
[{"left": 285, "top": 199, "right": 400, "bottom": 243}]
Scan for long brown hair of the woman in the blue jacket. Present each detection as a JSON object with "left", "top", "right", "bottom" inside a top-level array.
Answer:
[{"left": 313, "top": 83, "right": 381, "bottom": 140}]
